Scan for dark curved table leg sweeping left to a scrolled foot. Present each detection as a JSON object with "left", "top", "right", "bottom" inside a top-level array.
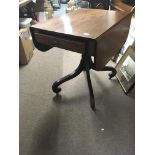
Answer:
[{"left": 52, "top": 59, "right": 84, "bottom": 93}]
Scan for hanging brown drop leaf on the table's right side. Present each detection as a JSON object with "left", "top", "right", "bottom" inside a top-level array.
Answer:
[{"left": 94, "top": 13, "right": 132, "bottom": 70}]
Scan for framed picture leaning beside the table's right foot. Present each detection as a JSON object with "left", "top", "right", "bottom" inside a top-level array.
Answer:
[{"left": 115, "top": 46, "right": 135, "bottom": 94}]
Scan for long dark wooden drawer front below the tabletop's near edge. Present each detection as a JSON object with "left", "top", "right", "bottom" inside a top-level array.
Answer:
[{"left": 34, "top": 33, "right": 85, "bottom": 53}]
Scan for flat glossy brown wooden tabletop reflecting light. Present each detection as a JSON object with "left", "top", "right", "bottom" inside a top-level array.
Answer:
[{"left": 32, "top": 9, "right": 127, "bottom": 39}]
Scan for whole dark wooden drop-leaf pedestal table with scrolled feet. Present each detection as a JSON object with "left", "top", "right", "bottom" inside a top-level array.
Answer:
[{"left": 30, "top": 9, "right": 132, "bottom": 110}]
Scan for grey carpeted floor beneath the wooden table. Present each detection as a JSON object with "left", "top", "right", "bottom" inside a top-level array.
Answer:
[{"left": 19, "top": 48, "right": 135, "bottom": 155}]
